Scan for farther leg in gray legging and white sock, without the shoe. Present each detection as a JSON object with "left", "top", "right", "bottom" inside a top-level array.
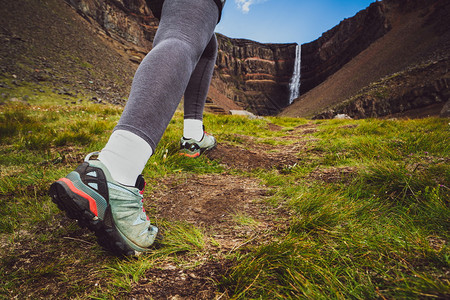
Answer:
[{"left": 183, "top": 34, "right": 217, "bottom": 141}]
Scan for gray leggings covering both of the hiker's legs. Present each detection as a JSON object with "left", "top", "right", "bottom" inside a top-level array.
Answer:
[{"left": 114, "top": 0, "right": 219, "bottom": 150}]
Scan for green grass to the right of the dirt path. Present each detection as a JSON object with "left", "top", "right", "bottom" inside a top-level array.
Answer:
[{"left": 224, "top": 119, "right": 450, "bottom": 299}]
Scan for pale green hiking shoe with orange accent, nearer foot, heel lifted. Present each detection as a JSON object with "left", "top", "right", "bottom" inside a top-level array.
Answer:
[{"left": 49, "top": 152, "right": 158, "bottom": 255}]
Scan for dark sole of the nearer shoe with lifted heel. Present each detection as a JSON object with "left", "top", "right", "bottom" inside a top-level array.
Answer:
[{"left": 49, "top": 180, "right": 140, "bottom": 256}]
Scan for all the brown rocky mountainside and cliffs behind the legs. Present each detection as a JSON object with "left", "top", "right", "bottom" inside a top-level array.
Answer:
[{"left": 0, "top": 0, "right": 450, "bottom": 118}]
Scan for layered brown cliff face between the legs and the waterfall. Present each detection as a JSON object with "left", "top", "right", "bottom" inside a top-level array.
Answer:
[{"left": 213, "top": 34, "right": 296, "bottom": 115}]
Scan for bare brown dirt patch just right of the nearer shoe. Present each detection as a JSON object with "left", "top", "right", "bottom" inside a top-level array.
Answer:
[{"left": 149, "top": 174, "right": 287, "bottom": 246}]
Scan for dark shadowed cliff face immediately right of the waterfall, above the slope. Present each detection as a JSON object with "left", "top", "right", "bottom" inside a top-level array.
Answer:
[{"left": 300, "top": 2, "right": 391, "bottom": 93}]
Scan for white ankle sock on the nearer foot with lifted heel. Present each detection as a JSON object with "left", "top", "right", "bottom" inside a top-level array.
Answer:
[{"left": 98, "top": 130, "right": 153, "bottom": 186}]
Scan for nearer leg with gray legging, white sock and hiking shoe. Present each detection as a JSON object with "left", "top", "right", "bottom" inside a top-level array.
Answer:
[{"left": 49, "top": 0, "right": 218, "bottom": 255}]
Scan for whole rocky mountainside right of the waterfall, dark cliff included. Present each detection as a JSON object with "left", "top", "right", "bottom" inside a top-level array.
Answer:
[{"left": 281, "top": 0, "right": 450, "bottom": 118}]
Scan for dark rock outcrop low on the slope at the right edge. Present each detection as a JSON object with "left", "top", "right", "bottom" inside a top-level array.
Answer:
[{"left": 314, "top": 59, "right": 450, "bottom": 119}]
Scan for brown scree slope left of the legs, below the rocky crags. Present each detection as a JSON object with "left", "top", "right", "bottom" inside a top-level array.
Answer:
[{"left": 0, "top": 0, "right": 135, "bottom": 104}]
